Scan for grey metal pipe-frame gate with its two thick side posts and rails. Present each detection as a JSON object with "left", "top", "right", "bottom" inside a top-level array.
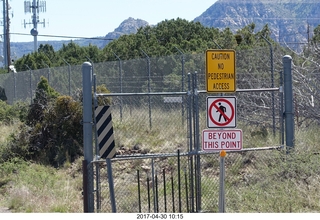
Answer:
[{"left": 82, "top": 54, "right": 294, "bottom": 212}]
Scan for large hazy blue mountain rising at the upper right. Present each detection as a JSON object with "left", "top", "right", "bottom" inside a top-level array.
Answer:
[{"left": 194, "top": 0, "right": 320, "bottom": 47}]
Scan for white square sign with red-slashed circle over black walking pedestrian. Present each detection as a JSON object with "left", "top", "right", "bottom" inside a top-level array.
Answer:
[{"left": 207, "top": 96, "right": 236, "bottom": 128}]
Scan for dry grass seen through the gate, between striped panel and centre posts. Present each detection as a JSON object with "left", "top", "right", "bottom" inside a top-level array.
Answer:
[{"left": 112, "top": 109, "right": 188, "bottom": 153}]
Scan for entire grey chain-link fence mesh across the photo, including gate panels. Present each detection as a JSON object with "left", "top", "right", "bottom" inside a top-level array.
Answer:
[{"left": 0, "top": 47, "right": 319, "bottom": 212}]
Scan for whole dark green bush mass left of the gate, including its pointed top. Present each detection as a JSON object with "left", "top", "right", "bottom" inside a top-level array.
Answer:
[{"left": 5, "top": 77, "right": 83, "bottom": 167}]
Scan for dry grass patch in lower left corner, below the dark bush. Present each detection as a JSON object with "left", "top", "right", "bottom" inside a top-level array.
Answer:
[{"left": 0, "top": 156, "right": 83, "bottom": 213}]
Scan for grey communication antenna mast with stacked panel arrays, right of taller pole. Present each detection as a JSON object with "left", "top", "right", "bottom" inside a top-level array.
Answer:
[{"left": 24, "top": 0, "right": 47, "bottom": 52}]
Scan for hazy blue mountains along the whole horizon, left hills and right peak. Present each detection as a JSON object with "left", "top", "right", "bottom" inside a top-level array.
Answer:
[{"left": 9, "top": 0, "right": 320, "bottom": 59}]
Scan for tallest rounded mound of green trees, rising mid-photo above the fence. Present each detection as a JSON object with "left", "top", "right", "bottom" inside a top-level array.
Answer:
[{"left": 103, "top": 18, "right": 229, "bottom": 60}]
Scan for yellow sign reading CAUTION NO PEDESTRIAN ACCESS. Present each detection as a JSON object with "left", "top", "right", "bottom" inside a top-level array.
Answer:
[{"left": 206, "top": 50, "right": 236, "bottom": 93}]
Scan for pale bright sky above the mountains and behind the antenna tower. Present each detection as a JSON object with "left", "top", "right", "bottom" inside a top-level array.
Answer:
[{"left": 6, "top": 0, "right": 217, "bottom": 42}]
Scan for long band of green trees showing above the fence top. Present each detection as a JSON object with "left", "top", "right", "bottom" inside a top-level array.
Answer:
[{"left": 7, "top": 19, "right": 319, "bottom": 72}]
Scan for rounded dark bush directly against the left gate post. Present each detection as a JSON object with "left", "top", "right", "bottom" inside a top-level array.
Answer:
[{"left": 25, "top": 96, "right": 83, "bottom": 167}]
